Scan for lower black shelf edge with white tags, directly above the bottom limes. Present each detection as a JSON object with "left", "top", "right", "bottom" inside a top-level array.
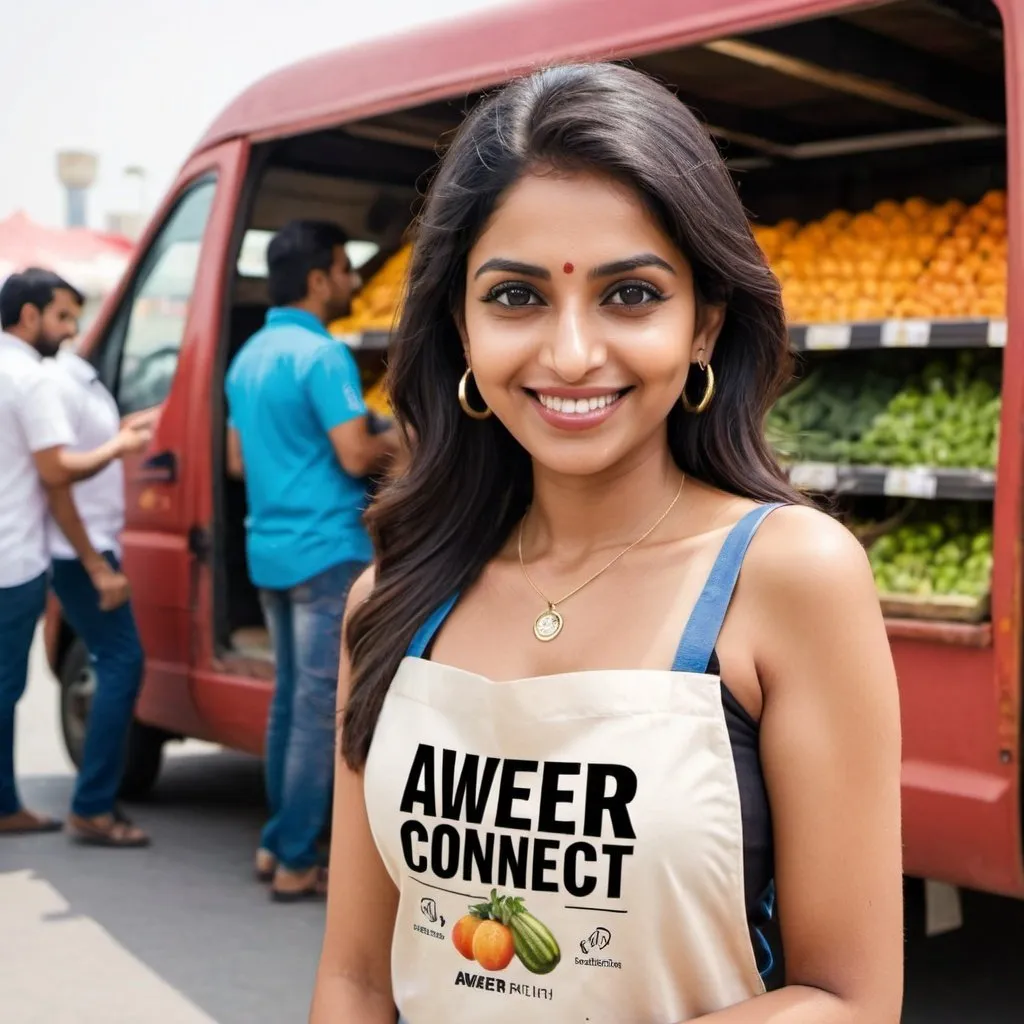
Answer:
[{"left": 790, "top": 462, "right": 995, "bottom": 501}]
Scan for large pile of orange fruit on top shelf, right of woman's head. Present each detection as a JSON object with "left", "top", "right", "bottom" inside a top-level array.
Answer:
[{"left": 754, "top": 191, "right": 1007, "bottom": 324}]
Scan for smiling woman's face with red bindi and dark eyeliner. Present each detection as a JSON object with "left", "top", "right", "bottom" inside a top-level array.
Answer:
[{"left": 464, "top": 174, "right": 724, "bottom": 475}]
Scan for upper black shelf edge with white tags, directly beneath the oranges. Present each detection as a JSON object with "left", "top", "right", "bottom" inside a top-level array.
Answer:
[{"left": 790, "top": 319, "right": 1007, "bottom": 352}]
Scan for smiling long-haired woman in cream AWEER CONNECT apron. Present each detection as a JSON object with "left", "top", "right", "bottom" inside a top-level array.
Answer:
[{"left": 311, "top": 65, "right": 902, "bottom": 1024}]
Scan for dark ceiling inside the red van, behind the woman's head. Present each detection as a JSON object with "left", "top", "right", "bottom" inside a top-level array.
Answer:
[{"left": 260, "top": 0, "right": 1006, "bottom": 223}]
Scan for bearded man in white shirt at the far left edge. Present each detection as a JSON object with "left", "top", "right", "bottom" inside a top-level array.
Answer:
[{"left": 0, "top": 269, "right": 148, "bottom": 838}]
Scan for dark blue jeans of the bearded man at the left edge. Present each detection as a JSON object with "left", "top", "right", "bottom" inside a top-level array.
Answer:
[{"left": 0, "top": 572, "right": 46, "bottom": 817}]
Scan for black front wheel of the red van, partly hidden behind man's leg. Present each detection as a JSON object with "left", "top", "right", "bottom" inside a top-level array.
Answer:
[{"left": 58, "top": 638, "right": 168, "bottom": 800}]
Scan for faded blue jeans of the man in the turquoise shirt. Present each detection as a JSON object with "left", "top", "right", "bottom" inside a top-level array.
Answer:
[{"left": 260, "top": 562, "right": 366, "bottom": 870}]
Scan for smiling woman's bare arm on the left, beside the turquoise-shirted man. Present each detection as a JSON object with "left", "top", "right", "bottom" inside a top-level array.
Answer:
[{"left": 309, "top": 570, "right": 398, "bottom": 1024}]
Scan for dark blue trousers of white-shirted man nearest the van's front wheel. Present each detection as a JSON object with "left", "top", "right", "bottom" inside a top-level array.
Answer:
[{"left": 53, "top": 552, "right": 144, "bottom": 818}]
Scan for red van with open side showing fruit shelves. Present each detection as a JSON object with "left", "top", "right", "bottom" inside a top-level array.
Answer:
[{"left": 47, "top": 0, "right": 1024, "bottom": 896}]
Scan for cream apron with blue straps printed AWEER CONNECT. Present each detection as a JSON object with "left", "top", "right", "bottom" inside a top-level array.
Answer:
[{"left": 366, "top": 506, "right": 776, "bottom": 1024}]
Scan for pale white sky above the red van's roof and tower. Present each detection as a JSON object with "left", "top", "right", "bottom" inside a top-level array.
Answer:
[{"left": 0, "top": 0, "right": 503, "bottom": 227}]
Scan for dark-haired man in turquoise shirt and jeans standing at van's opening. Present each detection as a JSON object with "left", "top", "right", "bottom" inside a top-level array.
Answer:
[{"left": 226, "top": 221, "right": 398, "bottom": 902}]
